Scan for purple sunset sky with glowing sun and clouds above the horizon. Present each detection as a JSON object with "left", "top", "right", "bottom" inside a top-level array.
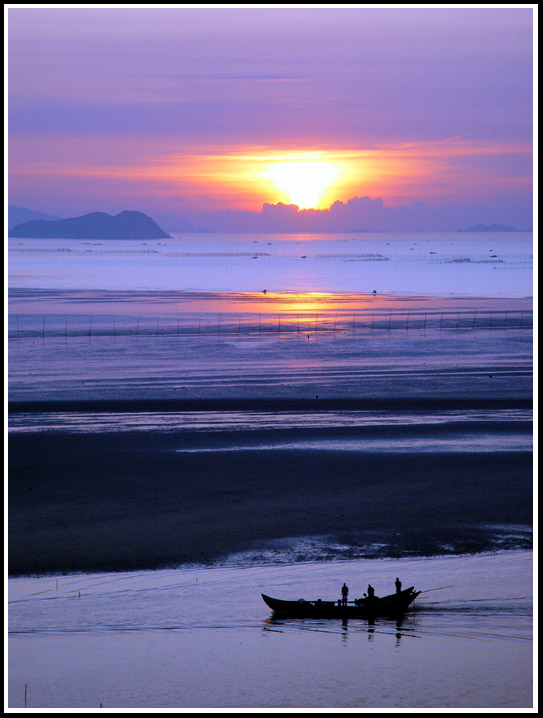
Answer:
[{"left": 8, "top": 6, "right": 533, "bottom": 231}]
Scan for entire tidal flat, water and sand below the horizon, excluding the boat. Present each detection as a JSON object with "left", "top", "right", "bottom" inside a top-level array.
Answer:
[{"left": 8, "top": 235, "right": 533, "bottom": 708}]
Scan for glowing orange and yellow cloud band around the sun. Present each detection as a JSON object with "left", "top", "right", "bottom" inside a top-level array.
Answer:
[{"left": 12, "top": 138, "right": 532, "bottom": 210}]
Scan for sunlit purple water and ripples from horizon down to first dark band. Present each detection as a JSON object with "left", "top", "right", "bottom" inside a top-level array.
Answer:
[{"left": 9, "top": 233, "right": 532, "bottom": 401}]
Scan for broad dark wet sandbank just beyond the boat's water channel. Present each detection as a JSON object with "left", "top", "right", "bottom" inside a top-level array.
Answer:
[{"left": 9, "top": 426, "right": 532, "bottom": 575}]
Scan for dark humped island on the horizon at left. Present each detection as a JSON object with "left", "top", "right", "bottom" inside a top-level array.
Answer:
[{"left": 8, "top": 210, "right": 170, "bottom": 239}]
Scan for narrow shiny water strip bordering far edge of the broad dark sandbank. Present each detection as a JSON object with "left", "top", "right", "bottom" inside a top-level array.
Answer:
[{"left": 8, "top": 409, "right": 532, "bottom": 453}]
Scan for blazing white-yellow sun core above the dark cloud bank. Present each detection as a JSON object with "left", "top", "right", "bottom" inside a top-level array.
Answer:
[{"left": 264, "top": 160, "right": 341, "bottom": 209}]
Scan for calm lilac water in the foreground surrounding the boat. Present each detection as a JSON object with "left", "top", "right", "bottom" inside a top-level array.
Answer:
[{"left": 9, "top": 552, "right": 532, "bottom": 708}]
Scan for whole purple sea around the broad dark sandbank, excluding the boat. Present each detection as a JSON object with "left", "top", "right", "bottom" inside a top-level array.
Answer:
[{"left": 7, "top": 232, "right": 535, "bottom": 711}]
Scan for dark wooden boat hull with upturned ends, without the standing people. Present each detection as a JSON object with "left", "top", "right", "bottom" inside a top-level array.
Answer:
[{"left": 262, "top": 586, "right": 420, "bottom": 618}]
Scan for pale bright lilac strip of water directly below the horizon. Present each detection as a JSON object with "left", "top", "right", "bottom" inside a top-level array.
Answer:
[{"left": 8, "top": 232, "right": 533, "bottom": 297}]
